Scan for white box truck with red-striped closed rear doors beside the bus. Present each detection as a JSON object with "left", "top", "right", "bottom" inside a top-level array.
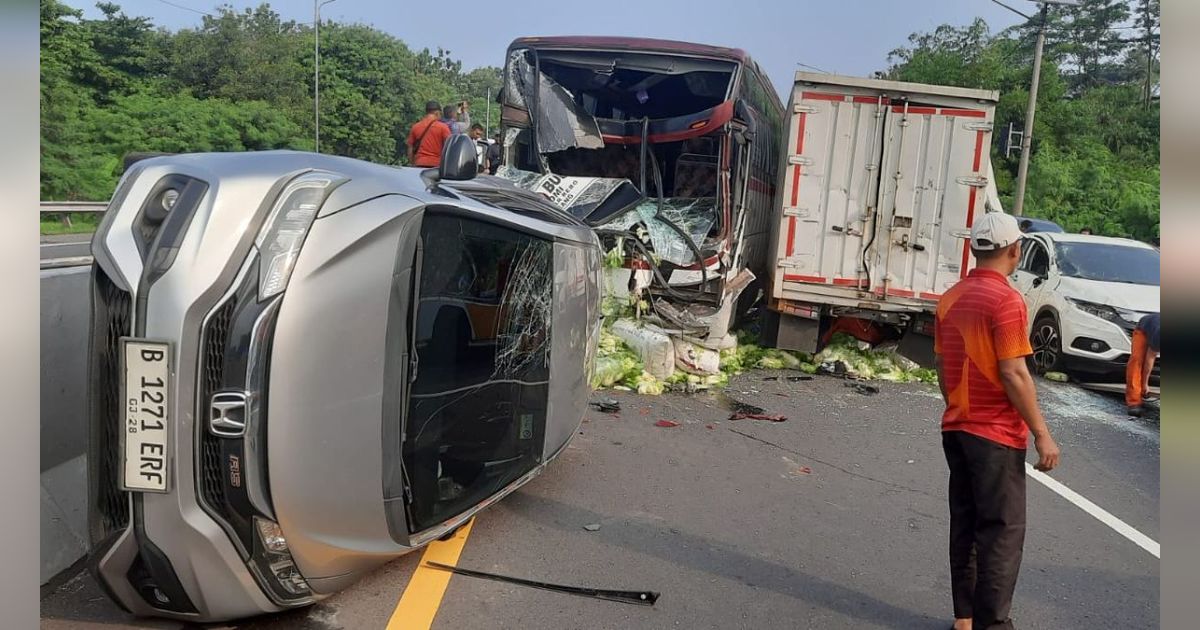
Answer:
[{"left": 763, "top": 72, "right": 1002, "bottom": 362}]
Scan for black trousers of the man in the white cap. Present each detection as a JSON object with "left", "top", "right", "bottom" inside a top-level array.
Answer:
[{"left": 942, "top": 431, "right": 1025, "bottom": 630}]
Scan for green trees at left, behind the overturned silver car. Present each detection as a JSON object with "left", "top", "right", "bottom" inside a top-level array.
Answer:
[{"left": 41, "top": 0, "right": 500, "bottom": 200}]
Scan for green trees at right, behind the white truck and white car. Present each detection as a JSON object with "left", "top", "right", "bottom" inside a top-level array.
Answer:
[{"left": 878, "top": 0, "right": 1159, "bottom": 240}]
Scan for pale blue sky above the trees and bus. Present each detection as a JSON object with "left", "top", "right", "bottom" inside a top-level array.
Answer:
[{"left": 65, "top": 0, "right": 1036, "bottom": 101}]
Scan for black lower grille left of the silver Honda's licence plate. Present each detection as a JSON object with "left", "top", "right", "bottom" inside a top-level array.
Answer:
[{"left": 88, "top": 265, "right": 132, "bottom": 545}]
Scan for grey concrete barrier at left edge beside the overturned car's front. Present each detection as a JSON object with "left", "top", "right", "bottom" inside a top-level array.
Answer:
[{"left": 41, "top": 266, "right": 91, "bottom": 584}]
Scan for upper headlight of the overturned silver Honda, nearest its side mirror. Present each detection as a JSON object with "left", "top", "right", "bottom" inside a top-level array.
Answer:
[{"left": 254, "top": 170, "right": 348, "bottom": 300}]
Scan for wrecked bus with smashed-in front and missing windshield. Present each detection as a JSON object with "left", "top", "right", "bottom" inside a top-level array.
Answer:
[{"left": 498, "top": 37, "right": 784, "bottom": 349}]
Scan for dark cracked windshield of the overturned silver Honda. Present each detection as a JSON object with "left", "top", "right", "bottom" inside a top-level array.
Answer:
[{"left": 403, "top": 214, "right": 554, "bottom": 533}]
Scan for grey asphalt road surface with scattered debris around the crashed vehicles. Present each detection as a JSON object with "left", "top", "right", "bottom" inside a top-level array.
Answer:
[{"left": 42, "top": 372, "right": 1159, "bottom": 630}]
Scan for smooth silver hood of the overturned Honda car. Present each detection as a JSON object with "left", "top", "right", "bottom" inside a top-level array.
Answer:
[{"left": 266, "top": 196, "right": 419, "bottom": 592}]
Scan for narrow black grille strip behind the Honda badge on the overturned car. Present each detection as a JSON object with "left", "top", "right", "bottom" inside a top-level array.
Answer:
[{"left": 198, "top": 298, "right": 238, "bottom": 510}]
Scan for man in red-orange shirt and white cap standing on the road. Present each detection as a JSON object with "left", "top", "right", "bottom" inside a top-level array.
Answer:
[{"left": 934, "top": 212, "right": 1060, "bottom": 630}]
